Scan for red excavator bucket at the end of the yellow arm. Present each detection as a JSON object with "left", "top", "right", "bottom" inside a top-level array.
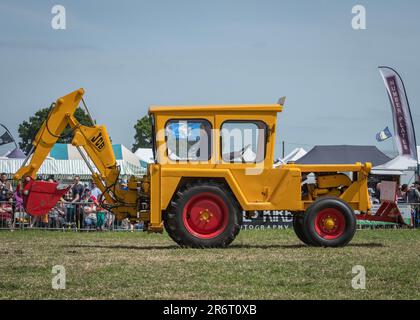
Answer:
[{"left": 22, "top": 178, "right": 71, "bottom": 216}]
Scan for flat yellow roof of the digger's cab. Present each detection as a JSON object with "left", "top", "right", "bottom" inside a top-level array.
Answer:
[{"left": 149, "top": 104, "right": 283, "bottom": 113}]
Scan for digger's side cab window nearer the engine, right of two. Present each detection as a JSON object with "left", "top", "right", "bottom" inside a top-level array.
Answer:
[{"left": 221, "top": 121, "right": 267, "bottom": 163}]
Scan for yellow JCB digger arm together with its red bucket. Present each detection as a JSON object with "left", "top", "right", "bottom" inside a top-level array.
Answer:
[{"left": 14, "top": 89, "right": 148, "bottom": 221}]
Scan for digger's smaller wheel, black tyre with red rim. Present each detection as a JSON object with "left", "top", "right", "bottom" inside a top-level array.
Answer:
[{"left": 303, "top": 197, "right": 356, "bottom": 247}]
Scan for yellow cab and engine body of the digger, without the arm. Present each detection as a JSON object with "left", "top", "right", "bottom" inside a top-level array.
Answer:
[{"left": 149, "top": 104, "right": 372, "bottom": 227}]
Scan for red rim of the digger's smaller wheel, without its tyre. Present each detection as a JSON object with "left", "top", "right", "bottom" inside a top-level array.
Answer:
[{"left": 315, "top": 208, "right": 346, "bottom": 240}]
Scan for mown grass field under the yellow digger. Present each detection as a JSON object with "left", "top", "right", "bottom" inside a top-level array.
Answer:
[{"left": 0, "top": 230, "right": 420, "bottom": 299}]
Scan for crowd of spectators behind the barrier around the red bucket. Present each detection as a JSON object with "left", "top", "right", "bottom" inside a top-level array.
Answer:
[{"left": 0, "top": 173, "right": 139, "bottom": 231}]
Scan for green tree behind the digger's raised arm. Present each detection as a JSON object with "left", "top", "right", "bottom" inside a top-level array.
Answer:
[{"left": 18, "top": 108, "right": 92, "bottom": 154}]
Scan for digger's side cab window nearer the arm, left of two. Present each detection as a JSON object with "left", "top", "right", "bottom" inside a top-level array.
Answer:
[{"left": 165, "top": 119, "right": 211, "bottom": 161}]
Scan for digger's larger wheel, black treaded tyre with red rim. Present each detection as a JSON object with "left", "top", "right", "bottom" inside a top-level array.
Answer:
[{"left": 164, "top": 181, "right": 242, "bottom": 248}]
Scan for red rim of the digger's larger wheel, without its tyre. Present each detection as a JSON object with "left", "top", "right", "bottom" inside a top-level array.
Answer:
[{"left": 182, "top": 192, "right": 229, "bottom": 239}]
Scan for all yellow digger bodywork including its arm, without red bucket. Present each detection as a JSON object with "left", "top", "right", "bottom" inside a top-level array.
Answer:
[{"left": 14, "top": 89, "right": 371, "bottom": 232}]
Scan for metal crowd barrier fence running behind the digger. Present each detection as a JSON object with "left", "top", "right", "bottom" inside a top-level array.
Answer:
[{"left": 0, "top": 201, "right": 420, "bottom": 231}]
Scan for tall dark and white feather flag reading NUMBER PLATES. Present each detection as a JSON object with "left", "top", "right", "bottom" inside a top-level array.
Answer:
[{"left": 379, "top": 67, "right": 417, "bottom": 161}]
